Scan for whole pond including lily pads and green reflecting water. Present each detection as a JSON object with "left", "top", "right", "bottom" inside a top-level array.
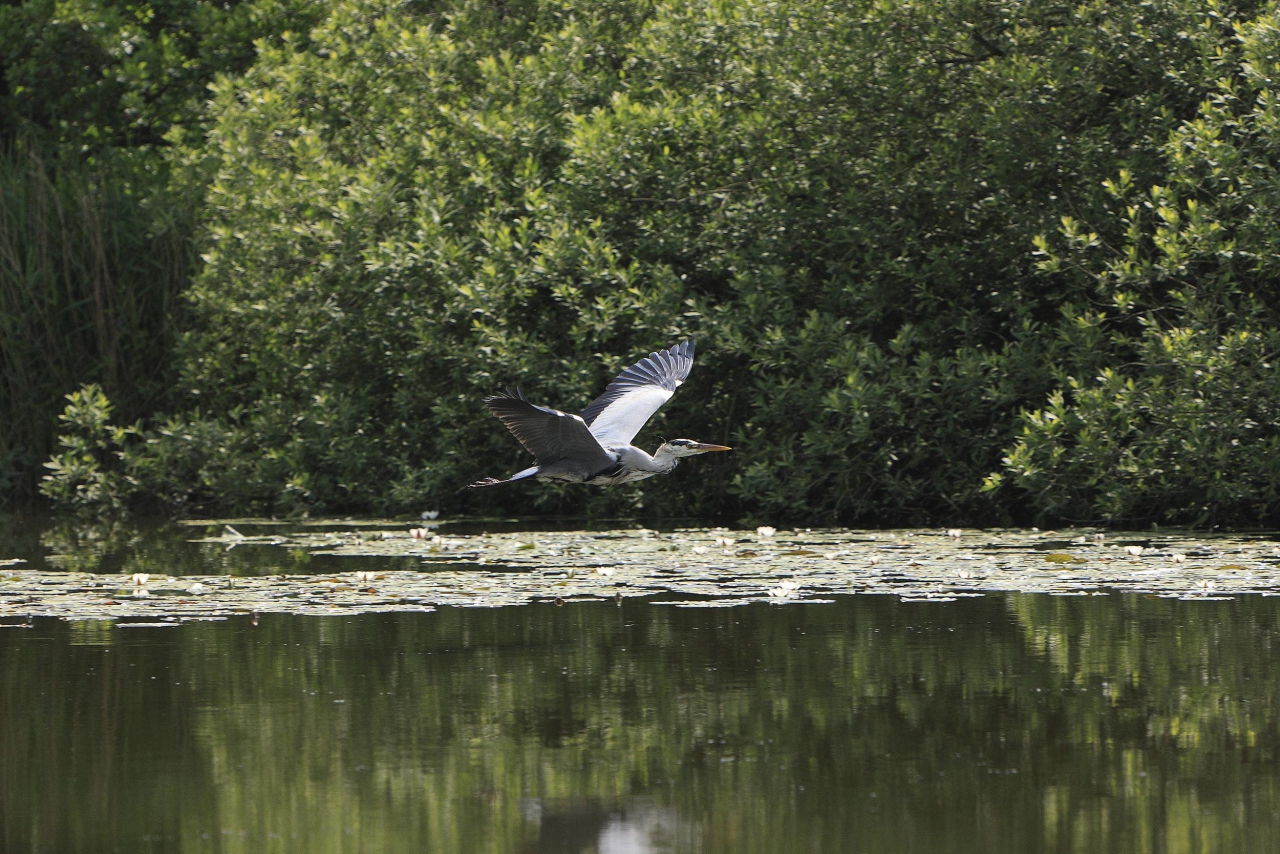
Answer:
[{"left": 0, "top": 520, "right": 1280, "bottom": 854}]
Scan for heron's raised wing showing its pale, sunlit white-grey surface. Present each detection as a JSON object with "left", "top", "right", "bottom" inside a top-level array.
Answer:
[{"left": 582, "top": 341, "right": 694, "bottom": 446}]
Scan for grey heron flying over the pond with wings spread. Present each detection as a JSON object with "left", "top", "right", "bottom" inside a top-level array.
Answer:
[{"left": 468, "top": 341, "right": 731, "bottom": 488}]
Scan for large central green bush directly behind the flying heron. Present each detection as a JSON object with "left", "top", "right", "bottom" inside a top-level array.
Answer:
[{"left": 131, "top": 0, "right": 1252, "bottom": 522}]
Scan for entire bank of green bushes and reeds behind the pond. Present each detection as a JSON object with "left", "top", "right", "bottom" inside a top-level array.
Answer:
[{"left": 0, "top": 0, "right": 1280, "bottom": 526}]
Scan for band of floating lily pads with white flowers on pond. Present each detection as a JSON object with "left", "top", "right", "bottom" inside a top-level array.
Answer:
[{"left": 0, "top": 520, "right": 1280, "bottom": 625}]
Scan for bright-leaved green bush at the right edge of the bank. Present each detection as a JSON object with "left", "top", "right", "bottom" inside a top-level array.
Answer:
[{"left": 992, "top": 10, "right": 1280, "bottom": 525}]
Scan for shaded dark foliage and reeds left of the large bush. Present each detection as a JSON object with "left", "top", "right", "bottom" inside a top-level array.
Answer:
[{"left": 0, "top": 0, "right": 319, "bottom": 504}]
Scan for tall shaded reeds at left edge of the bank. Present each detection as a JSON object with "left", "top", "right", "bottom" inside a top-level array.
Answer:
[{"left": 0, "top": 143, "right": 192, "bottom": 506}]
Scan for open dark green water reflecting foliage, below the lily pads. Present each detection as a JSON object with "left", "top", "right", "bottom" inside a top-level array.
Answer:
[{"left": 0, "top": 517, "right": 1280, "bottom": 854}]
